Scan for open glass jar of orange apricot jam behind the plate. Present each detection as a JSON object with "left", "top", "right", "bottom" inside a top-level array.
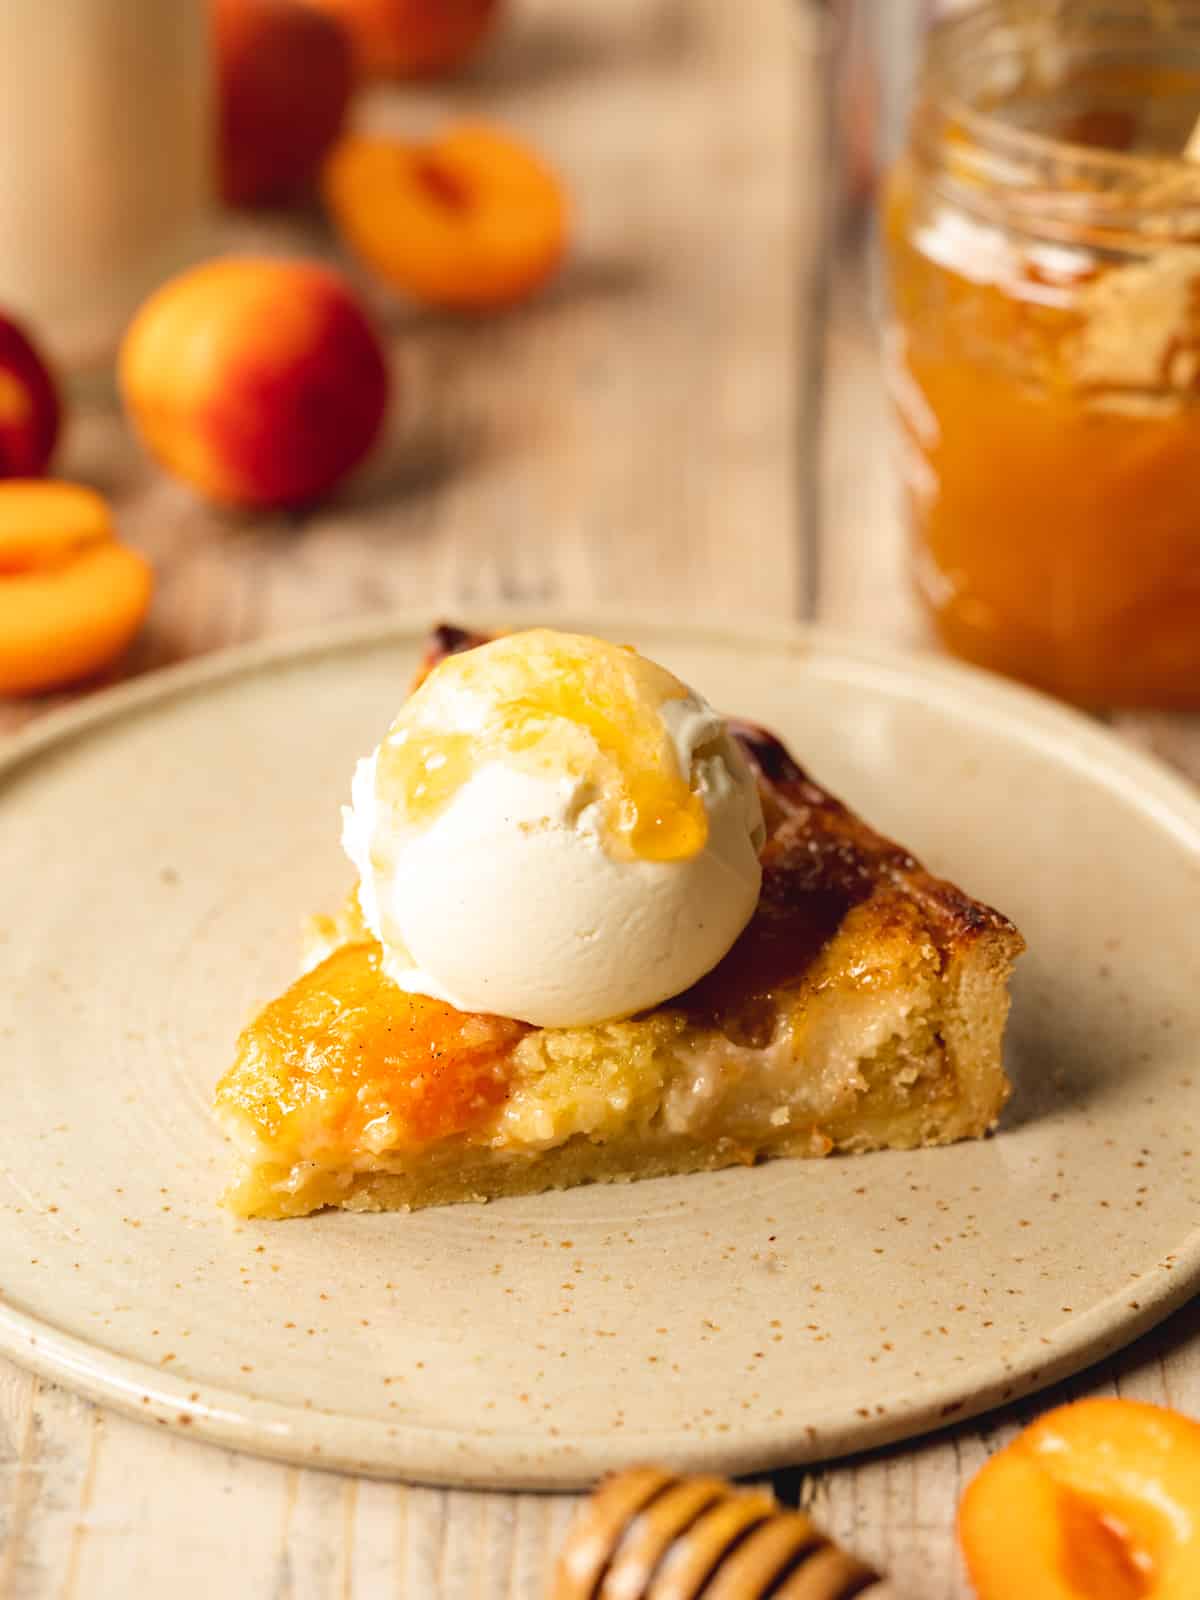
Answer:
[{"left": 883, "top": 0, "right": 1200, "bottom": 707}]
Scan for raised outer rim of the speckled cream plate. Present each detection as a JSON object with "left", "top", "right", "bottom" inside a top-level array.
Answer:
[{"left": 0, "top": 606, "right": 1200, "bottom": 1491}]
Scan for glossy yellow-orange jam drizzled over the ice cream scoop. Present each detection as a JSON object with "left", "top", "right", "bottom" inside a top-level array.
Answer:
[{"left": 378, "top": 629, "right": 709, "bottom": 861}]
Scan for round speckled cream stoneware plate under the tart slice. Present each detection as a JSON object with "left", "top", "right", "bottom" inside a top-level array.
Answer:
[{"left": 0, "top": 618, "right": 1200, "bottom": 1485}]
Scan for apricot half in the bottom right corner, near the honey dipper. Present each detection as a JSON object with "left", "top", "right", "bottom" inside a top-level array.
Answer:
[{"left": 958, "top": 1398, "right": 1200, "bottom": 1600}]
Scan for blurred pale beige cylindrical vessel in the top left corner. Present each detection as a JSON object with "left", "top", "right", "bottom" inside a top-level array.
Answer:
[{"left": 0, "top": 0, "right": 214, "bottom": 366}]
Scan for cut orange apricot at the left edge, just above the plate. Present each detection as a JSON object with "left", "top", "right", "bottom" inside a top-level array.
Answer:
[{"left": 0, "top": 478, "right": 154, "bottom": 694}]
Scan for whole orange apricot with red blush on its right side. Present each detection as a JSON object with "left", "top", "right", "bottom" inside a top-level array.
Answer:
[{"left": 120, "top": 256, "right": 389, "bottom": 506}]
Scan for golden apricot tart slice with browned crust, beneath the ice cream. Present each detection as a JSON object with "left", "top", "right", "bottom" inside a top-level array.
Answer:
[{"left": 216, "top": 629, "right": 1024, "bottom": 1218}]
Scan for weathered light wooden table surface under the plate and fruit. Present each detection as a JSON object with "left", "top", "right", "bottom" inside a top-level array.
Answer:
[{"left": 0, "top": 0, "right": 1200, "bottom": 1600}]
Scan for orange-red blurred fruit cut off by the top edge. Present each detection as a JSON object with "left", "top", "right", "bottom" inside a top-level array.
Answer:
[{"left": 307, "top": 0, "right": 499, "bottom": 77}]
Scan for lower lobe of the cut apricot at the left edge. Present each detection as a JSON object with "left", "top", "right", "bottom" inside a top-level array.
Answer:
[{"left": 0, "top": 541, "right": 154, "bottom": 694}]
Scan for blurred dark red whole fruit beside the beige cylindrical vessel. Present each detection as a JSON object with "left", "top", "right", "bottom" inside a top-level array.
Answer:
[{"left": 213, "top": 0, "right": 355, "bottom": 205}]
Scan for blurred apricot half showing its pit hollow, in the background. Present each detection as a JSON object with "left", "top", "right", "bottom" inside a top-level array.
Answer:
[{"left": 323, "top": 125, "right": 566, "bottom": 310}]
